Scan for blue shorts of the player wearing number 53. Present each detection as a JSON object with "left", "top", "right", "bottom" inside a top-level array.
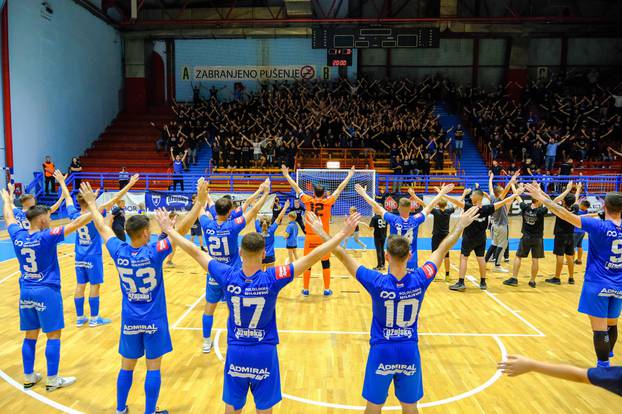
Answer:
[{"left": 119, "top": 318, "right": 173, "bottom": 359}]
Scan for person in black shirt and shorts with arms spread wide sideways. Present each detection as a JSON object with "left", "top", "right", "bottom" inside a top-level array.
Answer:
[{"left": 445, "top": 188, "right": 519, "bottom": 292}]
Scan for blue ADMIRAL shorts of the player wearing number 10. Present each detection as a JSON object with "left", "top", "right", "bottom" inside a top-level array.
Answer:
[{"left": 363, "top": 341, "right": 423, "bottom": 405}]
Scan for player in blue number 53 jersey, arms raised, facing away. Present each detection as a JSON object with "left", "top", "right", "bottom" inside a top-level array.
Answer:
[{"left": 80, "top": 183, "right": 207, "bottom": 414}]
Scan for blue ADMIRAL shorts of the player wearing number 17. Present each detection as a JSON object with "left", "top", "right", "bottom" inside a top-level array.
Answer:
[{"left": 222, "top": 345, "right": 282, "bottom": 410}]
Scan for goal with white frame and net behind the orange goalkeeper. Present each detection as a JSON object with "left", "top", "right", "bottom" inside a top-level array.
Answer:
[{"left": 296, "top": 169, "right": 376, "bottom": 216}]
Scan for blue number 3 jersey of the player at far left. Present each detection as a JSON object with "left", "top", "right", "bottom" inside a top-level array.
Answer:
[{"left": 8, "top": 224, "right": 65, "bottom": 288}]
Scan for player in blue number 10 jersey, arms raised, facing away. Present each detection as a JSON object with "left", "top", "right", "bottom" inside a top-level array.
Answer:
[{"left": 309, "top": 207, "right": 478, "bottom": 414}]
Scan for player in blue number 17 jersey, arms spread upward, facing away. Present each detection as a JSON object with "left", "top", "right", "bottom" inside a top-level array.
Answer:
[{"left": 156, "top": 211, "right": 361, "bottom": 414}]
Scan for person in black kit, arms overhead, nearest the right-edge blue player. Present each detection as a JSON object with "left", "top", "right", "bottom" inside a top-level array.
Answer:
[{"left": 545, "top": 181, "right": 581, "bottom": 285}]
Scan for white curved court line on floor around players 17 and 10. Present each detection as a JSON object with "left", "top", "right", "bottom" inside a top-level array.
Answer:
[{"left": 213, "top": 329, "right": 510, "bottom": 411}]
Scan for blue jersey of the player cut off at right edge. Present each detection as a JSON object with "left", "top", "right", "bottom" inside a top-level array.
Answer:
[{"left": 581, "top": 217, "right": 622, "bottom": 290}]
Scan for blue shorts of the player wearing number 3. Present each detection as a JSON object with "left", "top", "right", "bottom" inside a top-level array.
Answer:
[{"left": 19, "top": 286, "right": 65, "bottom": 333}]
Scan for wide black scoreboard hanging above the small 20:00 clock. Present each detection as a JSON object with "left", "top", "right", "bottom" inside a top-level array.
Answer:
[{"left": 312, "top": 26, "right": 440, "bottom": 49}]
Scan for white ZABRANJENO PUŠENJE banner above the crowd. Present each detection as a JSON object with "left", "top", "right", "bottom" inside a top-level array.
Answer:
[{"left": 179, "top": 64, "right": 317, "bottom": 82}]
